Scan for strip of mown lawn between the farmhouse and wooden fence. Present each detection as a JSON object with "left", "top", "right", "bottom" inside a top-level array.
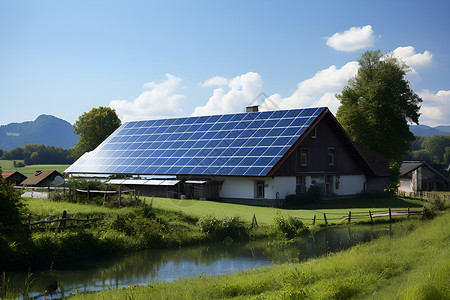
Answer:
[{"left": 150, "top": 197, "right": 421, "bottom": 225}]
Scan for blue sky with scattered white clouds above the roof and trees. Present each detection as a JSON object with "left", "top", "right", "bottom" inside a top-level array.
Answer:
[{"left": 0, "top": 0, "right": 450, "bottom": 126}]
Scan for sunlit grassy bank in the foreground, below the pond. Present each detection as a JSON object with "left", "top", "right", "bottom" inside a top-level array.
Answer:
[{"left": 71, "top": 213, "right": 450, "bottom": 299}]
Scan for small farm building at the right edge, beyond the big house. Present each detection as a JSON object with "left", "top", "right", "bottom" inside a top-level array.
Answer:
[{"left": 398, "top": 161, "right": 450, "bottom": 193}]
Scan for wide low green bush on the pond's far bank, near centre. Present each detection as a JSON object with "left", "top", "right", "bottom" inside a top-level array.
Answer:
[{"left": 198, "top": 217, "right": 248, "bottom": 241}]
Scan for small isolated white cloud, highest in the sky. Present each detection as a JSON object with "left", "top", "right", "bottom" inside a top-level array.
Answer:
[{"left": 327, "top": 25, "right": 375, "bottom": 52}]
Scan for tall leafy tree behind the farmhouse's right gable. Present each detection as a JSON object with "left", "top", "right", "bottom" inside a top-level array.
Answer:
[{"left": 336, "top": 50, "right": 422, "bottom": 162}]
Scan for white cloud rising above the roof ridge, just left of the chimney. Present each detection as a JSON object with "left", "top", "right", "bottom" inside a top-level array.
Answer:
[{"left": 192, "top": 72, "right": 263, "bottom": 116}]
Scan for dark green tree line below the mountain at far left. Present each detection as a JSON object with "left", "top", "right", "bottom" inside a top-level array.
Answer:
[{"left": 3, "top": 144, "right": 73, "bottom": 165}]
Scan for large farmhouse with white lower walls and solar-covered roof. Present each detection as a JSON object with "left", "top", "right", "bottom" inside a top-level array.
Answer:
[{"left": 66, "top": 107, "right": 388, "bottom": 204}]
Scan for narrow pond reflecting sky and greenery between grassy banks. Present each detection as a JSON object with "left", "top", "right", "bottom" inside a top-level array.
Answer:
[{"left": 5, "top": 224, "right": 391, "bottom": 299}]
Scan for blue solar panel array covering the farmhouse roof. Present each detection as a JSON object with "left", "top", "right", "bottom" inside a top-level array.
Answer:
[{"left": 66, "top": 107, "right": 325, "bottom": 176}]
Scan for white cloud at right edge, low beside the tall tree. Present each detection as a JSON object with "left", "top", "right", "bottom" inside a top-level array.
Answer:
[{"left": 418, "top": 90, "right": 450, "bottom": 126}]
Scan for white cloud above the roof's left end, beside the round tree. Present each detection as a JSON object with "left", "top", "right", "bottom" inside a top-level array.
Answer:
[{"left": 109, "top": 74, "right": 185, "bottom": 122}]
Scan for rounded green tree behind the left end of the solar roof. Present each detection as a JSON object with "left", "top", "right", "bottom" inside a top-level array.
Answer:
[{"left": 71, "top": 106, "right": 121, "bottom": 158}]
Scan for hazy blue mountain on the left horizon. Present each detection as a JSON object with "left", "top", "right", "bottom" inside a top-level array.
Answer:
[{"left": 0, "top": 115, "right": 79, "bottom": 151}]
